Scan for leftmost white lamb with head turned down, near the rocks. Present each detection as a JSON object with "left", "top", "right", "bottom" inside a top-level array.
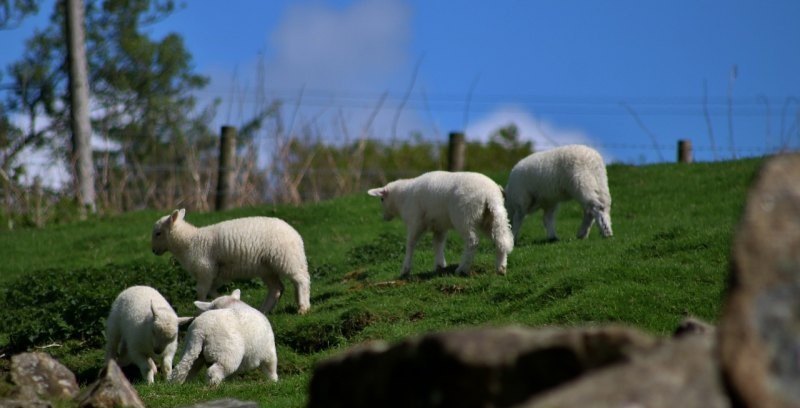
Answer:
[{"left": 106, "top": 286, "right": 192, "bottom": 384}]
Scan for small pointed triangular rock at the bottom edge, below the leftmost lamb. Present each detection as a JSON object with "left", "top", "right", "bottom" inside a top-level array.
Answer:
[{"left": 77, "top": 360, "right": 144, "bottom": 408}]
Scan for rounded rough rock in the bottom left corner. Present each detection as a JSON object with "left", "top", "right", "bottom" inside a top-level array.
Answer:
[{"left": 10, "top": 352, "right": 79, "bottom": 401}]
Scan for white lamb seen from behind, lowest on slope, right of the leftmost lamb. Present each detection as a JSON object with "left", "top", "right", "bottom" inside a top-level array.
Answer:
[{"left": 170, "top": 289, "right": 278, "bottom": 385}]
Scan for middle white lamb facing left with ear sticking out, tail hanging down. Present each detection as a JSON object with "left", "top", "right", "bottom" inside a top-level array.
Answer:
[{"left": 368, "top": 171, "right": 514, "bottom": 277}]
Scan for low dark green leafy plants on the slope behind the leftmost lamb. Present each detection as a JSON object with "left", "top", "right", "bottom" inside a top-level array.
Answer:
[{"left": 0, "top": 265, "right": 194, "bottom": 353}]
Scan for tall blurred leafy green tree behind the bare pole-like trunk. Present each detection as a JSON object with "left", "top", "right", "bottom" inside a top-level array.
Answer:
[{"left": 0, "top": 0, "right": 222, "bottom": 215}]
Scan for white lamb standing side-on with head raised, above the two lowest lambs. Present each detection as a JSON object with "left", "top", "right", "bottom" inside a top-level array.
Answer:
[{"left": 152, "top": 209, "right": 311, "bottom": 314}]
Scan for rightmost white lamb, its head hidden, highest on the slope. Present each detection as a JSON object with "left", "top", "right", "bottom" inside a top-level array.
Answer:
[{"left": 506, "top": 145, "right": 613, "bottom": 240}]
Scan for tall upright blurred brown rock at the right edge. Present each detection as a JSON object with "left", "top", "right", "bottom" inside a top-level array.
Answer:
[{"left": 718, "top": 155, "right": 800, "bottom": 407}]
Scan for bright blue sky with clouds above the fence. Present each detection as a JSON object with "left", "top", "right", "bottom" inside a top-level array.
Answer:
[{"left": 0, "top": 0, "right": 800, "bottom": 163}]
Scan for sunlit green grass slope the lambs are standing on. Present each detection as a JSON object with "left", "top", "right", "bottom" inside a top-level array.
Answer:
[{"left": 0, "top": 160, "right": 760, "bottom": 407}]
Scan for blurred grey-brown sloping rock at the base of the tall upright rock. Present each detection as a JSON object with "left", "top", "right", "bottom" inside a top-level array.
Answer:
[{"left": 518, "top": 336, "right": 731, "bottom": 408}]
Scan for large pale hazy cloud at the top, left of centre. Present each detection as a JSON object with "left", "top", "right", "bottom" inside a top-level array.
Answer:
[{"left": 210, "top": 0, "right": 424, "bottom": 141}]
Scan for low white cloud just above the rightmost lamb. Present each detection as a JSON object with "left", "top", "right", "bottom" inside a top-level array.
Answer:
[{"left": 466, "top": 105, "right": 613, "bottom": 163}]
